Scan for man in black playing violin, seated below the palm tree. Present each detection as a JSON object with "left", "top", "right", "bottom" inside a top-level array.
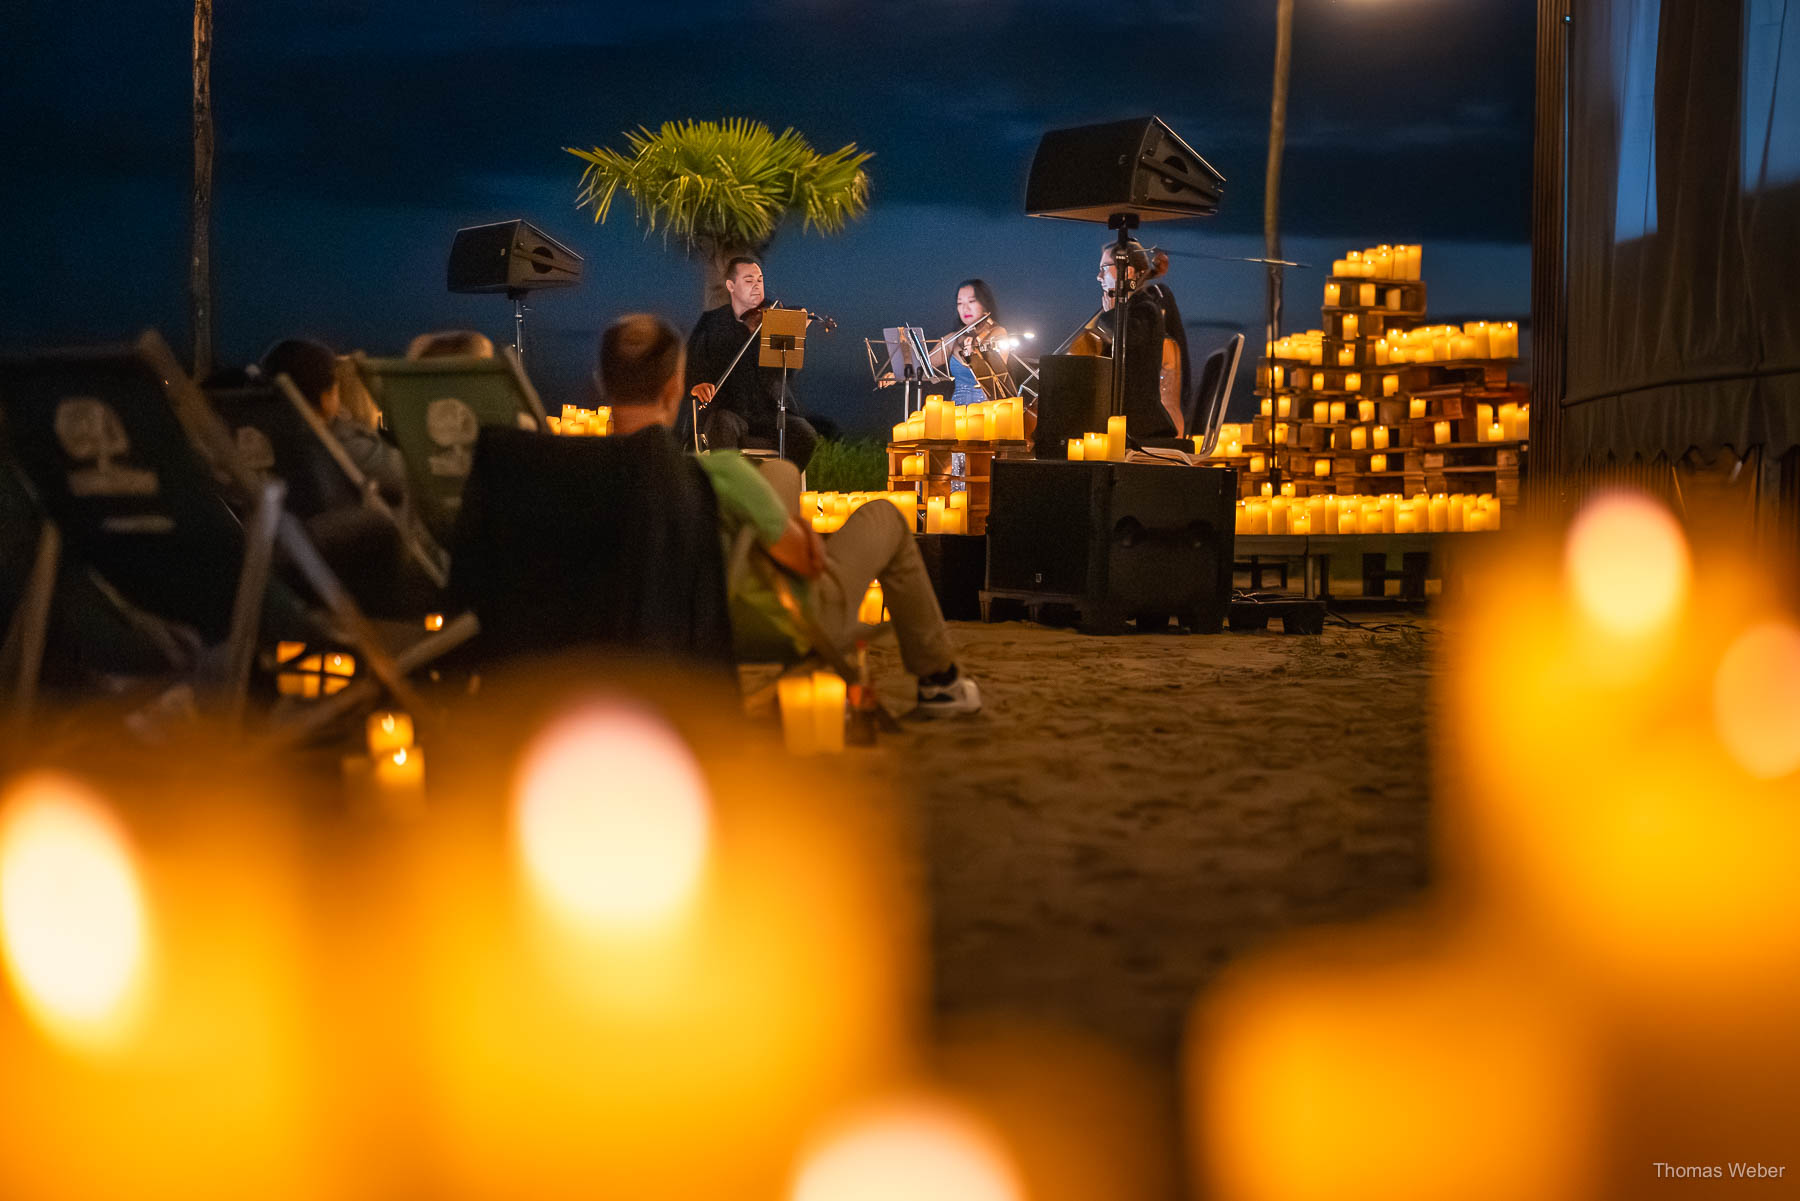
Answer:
[{"left": 688, "top": 256, "right": 819, "bottom": 472}]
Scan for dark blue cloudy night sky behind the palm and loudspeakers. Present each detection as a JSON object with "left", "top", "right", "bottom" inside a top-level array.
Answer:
[{"left": 0, "top": 0, "right": 1534, "bottom": 430}]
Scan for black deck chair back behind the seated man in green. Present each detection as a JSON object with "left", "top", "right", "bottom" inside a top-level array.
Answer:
[{"left": 450, "top": 425, "right": 733, "bottom": 672}]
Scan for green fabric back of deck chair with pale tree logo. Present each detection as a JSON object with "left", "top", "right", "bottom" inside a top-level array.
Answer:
[{"left": 356, "top": 346, "right": 549, "bottom": 546}]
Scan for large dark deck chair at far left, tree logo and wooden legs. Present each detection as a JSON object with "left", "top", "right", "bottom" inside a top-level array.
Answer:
[{"left": 0, "top": 331, "right": 472, "bottom": 733}]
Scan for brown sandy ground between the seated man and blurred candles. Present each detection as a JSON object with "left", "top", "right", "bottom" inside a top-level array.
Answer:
[{"left": 875, "top": 618, "right": 1435, "bottom": 1084}]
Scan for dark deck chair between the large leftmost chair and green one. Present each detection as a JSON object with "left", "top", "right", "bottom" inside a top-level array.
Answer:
[{"left": 207, "top": 375, "right": 450, "bottom": 589}]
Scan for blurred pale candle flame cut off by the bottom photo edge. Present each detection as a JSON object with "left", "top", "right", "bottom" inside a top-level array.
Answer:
[{"left": 788, "top": 1100, "right": 1024, "bottom": 1201}]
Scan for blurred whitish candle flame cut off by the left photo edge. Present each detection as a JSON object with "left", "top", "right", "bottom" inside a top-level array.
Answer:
[{"left": 0, "top": 774, "right": 149, "bottom": 1046}]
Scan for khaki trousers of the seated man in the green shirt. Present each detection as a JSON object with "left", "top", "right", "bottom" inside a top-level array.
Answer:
[{"left": 761, "top": 459, "right": 956, "bottom": 675}]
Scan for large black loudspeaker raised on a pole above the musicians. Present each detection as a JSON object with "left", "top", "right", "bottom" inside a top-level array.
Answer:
[{"left": 1024, "top": 117, "right": 1226, "bottom": 221}]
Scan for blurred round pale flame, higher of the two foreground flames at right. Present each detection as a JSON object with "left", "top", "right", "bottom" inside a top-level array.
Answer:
[{"left": 1564, "top": 493, "right": 1690, "bottom": 637}]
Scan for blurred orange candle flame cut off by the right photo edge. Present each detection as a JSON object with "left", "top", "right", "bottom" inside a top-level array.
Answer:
[{"left": 1712, "top": 621, "right": 1800, "bottom": 780}]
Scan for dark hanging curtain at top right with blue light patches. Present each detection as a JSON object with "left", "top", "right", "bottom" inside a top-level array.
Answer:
[{"left": 1559, "top": 0, "right": 1800, "bottom": 468}]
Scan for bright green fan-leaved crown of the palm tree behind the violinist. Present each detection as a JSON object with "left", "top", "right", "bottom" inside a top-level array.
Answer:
[{"left": 565, "top": 117, "right": 871, "bottom": 308}]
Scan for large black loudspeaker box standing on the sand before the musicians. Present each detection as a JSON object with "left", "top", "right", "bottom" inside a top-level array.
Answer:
[{"left": 986, "top": 459, "right": 1237, "bottom": 634}]
